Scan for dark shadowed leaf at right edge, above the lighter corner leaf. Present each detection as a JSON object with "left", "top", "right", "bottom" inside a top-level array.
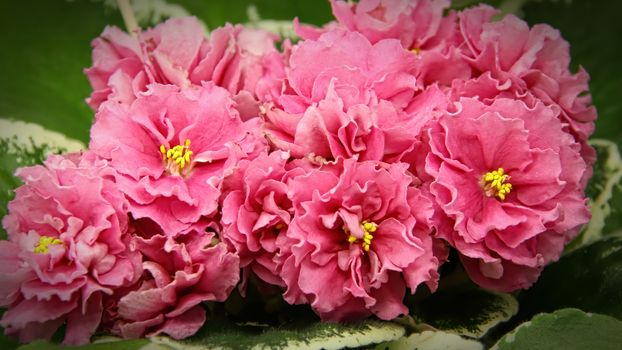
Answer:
[{"left": 519, "top": 236, "right": 622, "bottom": 320}]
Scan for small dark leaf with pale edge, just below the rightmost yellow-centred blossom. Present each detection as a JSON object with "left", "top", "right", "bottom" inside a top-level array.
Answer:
[{"left": 413, "top": 288, "right": 518, "bottom": 338}]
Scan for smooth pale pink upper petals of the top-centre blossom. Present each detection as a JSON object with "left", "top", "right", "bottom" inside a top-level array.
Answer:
[{"left": 270, "top": 30, "right": 415, "bottom": 113}]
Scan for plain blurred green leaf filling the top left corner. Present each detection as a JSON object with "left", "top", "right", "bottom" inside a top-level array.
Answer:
[{"left": 0, "top": 0, "right": 122, "bottom": 142}]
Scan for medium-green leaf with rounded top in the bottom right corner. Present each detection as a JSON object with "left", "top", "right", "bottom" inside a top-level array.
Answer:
[{"left": 492, "top": 309, "right": 622, "bottom": 350}]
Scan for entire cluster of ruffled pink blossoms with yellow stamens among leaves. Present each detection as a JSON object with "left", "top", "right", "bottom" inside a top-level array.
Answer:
[{"left": 0, "top": 0, "right": 596, "bottom": 344}]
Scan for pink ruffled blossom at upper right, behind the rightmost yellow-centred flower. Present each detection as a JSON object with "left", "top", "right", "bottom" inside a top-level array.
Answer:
[{"left": 459, "top": 5, "right": 596, "bottom": 160}]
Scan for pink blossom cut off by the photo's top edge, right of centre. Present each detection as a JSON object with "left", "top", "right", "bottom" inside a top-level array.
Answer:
[{"left": 294, "top": 0, "right": 471, "bottom": 89}]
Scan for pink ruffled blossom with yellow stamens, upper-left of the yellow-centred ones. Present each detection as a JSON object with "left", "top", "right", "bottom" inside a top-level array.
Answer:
[{"left": 90, "top": 83, "right": 264, "bottom": 234}]
